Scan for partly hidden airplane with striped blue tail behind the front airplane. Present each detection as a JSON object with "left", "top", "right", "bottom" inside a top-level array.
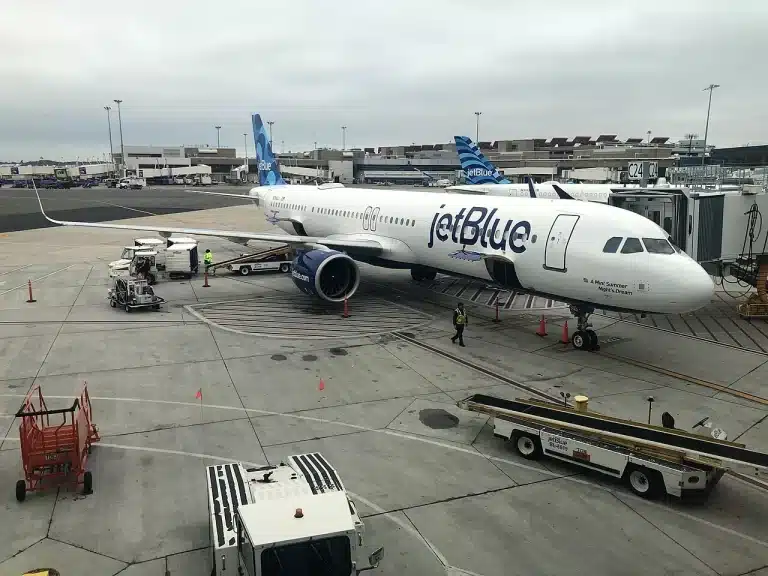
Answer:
[{"left": 446, "top": 136, "right": 638, "bottom": 204}]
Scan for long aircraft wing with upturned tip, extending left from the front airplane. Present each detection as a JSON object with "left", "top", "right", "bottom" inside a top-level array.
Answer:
[{"left": 35, "top": 187, "right": 383, "bottom": 254}]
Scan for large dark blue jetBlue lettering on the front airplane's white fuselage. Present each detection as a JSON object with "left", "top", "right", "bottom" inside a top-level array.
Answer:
[{"left": 427, "top": 204, "right": 531, "bottom": 254}]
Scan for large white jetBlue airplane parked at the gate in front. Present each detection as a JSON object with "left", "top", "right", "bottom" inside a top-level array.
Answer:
[{"left": 30, "top": 114, "right": 714, "bottom": 350}]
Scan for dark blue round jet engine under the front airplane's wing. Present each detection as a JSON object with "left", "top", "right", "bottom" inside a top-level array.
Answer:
[{"left": 291, "top": 250, "right": 360, "bottom": 302}]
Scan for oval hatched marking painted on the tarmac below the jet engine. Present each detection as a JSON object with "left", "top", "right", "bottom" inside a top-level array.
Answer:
[{"left": 184, "top": 294, "right": 432, "bottom": 339}]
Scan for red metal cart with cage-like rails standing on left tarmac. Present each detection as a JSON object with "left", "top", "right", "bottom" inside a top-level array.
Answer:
[{"left": 16, "top": 383, "right": 100, "bottom": 502}]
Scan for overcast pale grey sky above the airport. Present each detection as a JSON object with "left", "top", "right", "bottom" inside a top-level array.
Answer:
[{"left": 0, "top": 0, "right": 768, "bottom": 161}]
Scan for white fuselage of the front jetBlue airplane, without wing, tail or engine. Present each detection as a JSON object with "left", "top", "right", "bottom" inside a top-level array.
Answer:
[{"left": 250, "top": 186, "right": 714, "bottom": 313}]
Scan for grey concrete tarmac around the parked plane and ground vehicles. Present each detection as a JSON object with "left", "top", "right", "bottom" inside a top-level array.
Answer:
[{"left": 0, "top": 187, "right": 768, "bottom": 576}]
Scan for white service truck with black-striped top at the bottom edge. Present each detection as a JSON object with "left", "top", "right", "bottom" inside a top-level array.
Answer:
[{"left": 206, "top": 452, "right": 383, "bottom": 576}]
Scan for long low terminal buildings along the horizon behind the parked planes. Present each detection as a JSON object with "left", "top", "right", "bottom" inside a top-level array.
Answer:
[{"left": 6, "top": 134, "right": 768, "bottom": 185}]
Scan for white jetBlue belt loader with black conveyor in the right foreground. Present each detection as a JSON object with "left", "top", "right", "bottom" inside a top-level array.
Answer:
[{"left": 457, "top": 394, "right": 768, "bottom": 498}]
